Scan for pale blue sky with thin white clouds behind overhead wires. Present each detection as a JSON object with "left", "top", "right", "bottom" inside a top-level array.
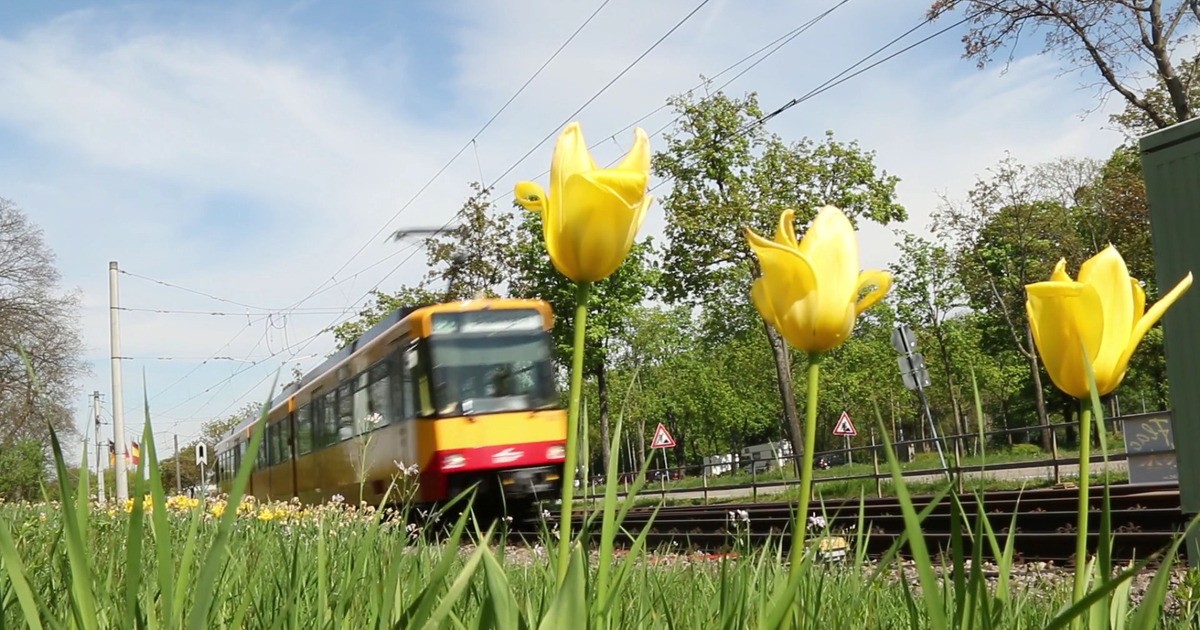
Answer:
[{"left": 0, "top": 0, "right": 1142, "bottom": 460}]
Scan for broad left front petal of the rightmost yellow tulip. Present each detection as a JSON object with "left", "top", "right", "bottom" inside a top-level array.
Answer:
[{"left": 1025, "top": 281, "right": 1106, "bottom": 398}]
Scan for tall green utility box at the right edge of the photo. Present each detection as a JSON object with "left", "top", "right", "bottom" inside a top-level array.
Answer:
[{"left": 1140, "top": 119, "right": 1200, "bottom": 559}]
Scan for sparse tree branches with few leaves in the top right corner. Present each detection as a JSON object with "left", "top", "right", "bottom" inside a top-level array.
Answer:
[{"left": 929, "top": 0, "right": 1200, "bottom": 130}]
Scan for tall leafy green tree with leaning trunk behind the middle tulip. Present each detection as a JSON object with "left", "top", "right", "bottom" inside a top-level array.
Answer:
[{"left": 654, "top": 92, "right": 906, "bottom": 470}]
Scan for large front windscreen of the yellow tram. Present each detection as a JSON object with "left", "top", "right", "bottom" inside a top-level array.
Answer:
[{"left": 430, "top": 331, "right": 554, "bottom": 415}]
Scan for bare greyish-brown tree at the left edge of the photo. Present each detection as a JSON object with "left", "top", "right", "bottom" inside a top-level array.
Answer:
[{"left": 0, "top": 199, "right": 88, "bottom": 449}]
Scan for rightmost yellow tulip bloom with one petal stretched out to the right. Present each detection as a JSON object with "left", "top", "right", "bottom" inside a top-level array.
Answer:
[{"left": 1025, "top": 245, "right": 1192, "bottom": 398}]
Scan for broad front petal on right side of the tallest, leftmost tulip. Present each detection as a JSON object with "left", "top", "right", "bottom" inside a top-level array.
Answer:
[{"left": 559, "top": 169, "right": 648, "bottom": 282}]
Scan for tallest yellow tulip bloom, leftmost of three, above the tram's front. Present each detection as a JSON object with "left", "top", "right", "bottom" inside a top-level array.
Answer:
[{"left": 514, "top": 122, "right": 652, "bottom": 282}]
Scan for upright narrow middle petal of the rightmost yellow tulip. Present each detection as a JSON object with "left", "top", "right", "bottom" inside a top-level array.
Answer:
[{"left": 1079, "top": 245, "right": 1135, "bottom": 391}]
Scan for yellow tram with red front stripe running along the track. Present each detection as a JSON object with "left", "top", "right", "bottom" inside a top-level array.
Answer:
[{"left": 214, "top": 299, "right": 566, "bottom": 508}]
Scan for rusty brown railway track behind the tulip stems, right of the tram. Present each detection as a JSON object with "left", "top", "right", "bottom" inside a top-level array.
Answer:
[{"left": 514, "top": 484, "right": 1187, "bottom": 566}]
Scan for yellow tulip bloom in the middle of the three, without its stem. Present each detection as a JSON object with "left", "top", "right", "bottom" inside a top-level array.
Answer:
[{"left": 746, "top": 205, "right": 892, "bottom": 354}]
